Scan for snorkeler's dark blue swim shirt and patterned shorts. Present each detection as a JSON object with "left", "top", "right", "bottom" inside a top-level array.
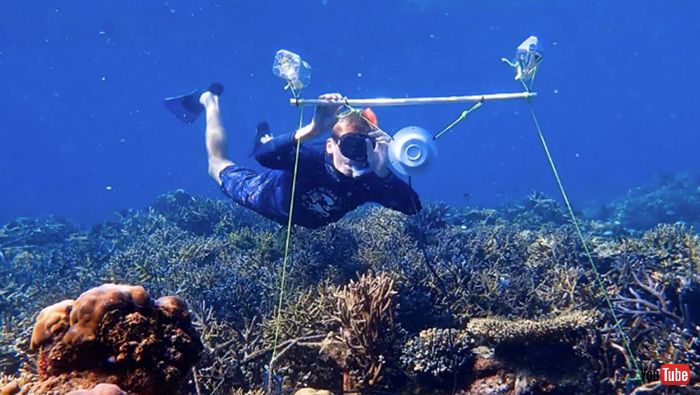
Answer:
[{"left": 221, "top": 133, "right": 421, "bottom": 228}]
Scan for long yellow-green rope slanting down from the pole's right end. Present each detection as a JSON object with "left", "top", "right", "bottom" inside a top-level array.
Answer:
[{"left": 528, "top": 100, "right": 642, "bottom": 380}]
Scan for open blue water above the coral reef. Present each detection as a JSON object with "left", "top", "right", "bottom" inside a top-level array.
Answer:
[{"left": 0, "top": 0, "right": 700, "bottom": 224}]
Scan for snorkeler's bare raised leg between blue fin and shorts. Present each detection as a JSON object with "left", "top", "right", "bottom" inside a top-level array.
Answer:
[{"left": 199, "top": 92, "right": 233, "bottom": 185}]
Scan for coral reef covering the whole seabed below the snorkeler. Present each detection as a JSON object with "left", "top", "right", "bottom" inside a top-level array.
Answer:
[{"left": 0, "top": 186, "right": 700, "bottom": 394}]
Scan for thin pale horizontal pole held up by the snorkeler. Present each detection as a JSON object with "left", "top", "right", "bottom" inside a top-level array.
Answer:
[{"left": 289, "top": 92, "right": 537, "bottom": 107}]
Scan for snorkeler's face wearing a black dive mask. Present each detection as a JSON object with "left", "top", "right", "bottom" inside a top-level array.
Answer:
[{"left": 326, "top": 121, "right": 369, "bottom": 178}]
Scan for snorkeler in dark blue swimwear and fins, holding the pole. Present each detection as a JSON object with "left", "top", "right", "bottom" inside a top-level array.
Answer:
[{"left": 165, "top": 83, "right": 421, "bottom": 228}]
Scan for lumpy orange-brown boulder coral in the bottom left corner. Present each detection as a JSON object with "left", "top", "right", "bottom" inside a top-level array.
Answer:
[{"left": 5, "top": 284, "right": 203, "bottom": 395}]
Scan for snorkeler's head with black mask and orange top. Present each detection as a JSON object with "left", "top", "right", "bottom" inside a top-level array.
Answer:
[{"left": 326, "top": 108, "right": 378, "bottom": 178}]
